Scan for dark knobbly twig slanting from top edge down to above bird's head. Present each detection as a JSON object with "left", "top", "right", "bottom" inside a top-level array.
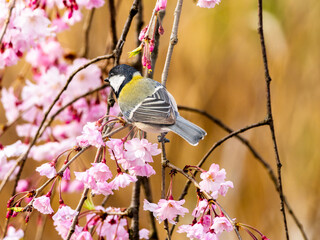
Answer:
[{"left": 114, "top": 0, "right": 140, "bottom": 65}]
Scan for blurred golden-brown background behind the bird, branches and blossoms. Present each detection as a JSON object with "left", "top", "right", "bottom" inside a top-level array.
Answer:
[{"left": 0, "top": 0, "right": 320, "bottom": 240}]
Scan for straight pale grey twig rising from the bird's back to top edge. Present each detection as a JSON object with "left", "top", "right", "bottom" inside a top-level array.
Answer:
[{"left": 161, "top": 0, "right": 183, "bottom": 86}]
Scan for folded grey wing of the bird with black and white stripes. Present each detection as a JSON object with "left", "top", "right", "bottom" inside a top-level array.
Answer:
[{"left": 129, "top": 86, "right": 177, "bottom": 125}]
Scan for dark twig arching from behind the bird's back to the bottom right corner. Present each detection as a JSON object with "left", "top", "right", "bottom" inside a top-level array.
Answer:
[{"left": 179, "top": 106, "right": 308, "bottom": 240}]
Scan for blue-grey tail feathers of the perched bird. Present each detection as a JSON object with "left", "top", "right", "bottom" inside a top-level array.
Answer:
[{"left": 169, "top": 115, "right": 207, "bottom": 146}]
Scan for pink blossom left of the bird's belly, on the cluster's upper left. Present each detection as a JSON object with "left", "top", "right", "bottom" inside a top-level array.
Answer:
[{"left": 77, "top": 122, "right": 105, "bottom": 148}]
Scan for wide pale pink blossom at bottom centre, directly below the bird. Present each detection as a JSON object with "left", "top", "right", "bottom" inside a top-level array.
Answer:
[{"left": 143, "top": 199, "right": 189, "bottom": 224}]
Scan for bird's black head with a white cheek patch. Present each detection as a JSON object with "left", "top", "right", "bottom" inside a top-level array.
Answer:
[{"left": 105, "top": 64, "right": 140, "bottom": 97}]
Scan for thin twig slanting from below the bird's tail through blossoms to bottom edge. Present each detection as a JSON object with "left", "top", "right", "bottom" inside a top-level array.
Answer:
[{"left": 166, "top": 162, "right": 241, "bottom": 240}]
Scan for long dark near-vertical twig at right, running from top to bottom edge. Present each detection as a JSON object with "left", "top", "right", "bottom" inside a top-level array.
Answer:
[{"left": 258, "top": 0, "right": 289, "bottom": 240}]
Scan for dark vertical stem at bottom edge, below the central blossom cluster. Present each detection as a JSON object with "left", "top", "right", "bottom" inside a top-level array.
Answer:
[{"left": 130, "top": 177, "right": 141, "bottom": 240}]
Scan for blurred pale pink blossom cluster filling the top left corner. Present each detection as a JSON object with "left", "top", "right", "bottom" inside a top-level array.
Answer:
[{"left": 0, "top": 0, "right": 104, "bottom": 69}]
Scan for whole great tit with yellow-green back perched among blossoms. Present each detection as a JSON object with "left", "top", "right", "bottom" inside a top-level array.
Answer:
[{"left": 105, "top": 64, "right": 207, "bottom": 146}]
